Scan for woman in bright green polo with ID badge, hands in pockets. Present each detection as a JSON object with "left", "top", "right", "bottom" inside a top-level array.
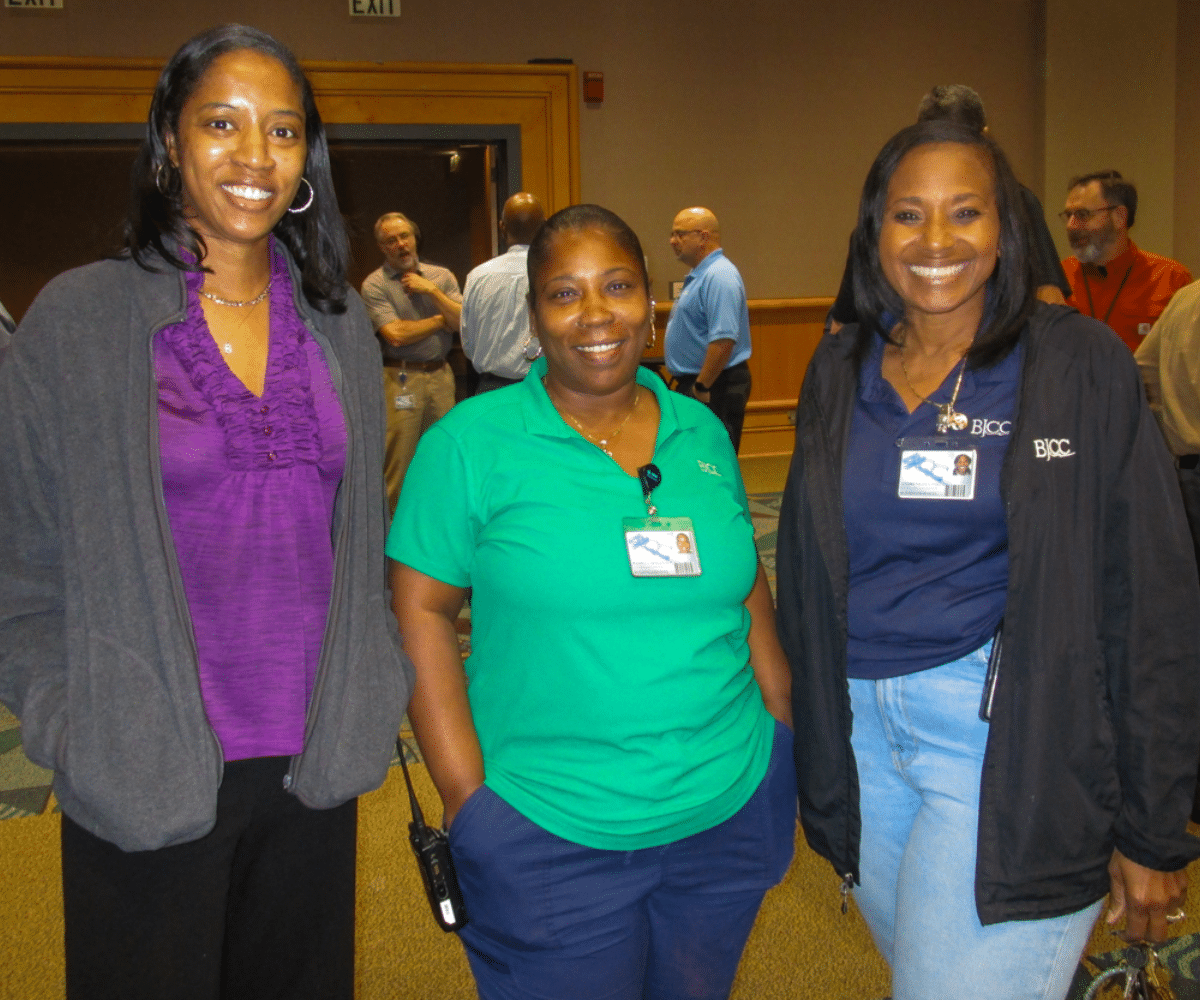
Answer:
[{"left": 388, "top": 205, "right": 796, "bottom": 1000}]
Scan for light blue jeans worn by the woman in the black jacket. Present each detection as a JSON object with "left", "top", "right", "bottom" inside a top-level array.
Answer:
[{"left": 850, "top": 642, "right": 1104, "bottom": 1000}]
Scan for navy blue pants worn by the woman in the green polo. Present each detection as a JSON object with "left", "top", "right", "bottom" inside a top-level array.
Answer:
[{"left": 450, "top": 723, "right": 796, "bottom": 1000}]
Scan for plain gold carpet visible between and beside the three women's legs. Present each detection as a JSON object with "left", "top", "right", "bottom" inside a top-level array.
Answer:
[{"left": 0, "top": 749, "right": 888, "bottom": 1000}]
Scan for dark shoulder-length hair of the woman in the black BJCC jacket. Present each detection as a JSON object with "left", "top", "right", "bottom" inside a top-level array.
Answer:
[{"left": 850, "top": 120, "right": 1037, "bottom": 369}]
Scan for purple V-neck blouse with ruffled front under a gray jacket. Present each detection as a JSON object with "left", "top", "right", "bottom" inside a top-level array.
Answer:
[{"left": 154, "top": 246, "right": 346, "bottom": 760}]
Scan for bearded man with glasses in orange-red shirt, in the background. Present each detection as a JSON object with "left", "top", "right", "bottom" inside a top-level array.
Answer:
[{"left": 1058, "top": 170, "right": 1192, "bottom": 351}]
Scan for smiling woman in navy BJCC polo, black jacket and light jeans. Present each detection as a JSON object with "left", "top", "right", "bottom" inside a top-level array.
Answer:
[{"left": 778, "top": 121, "right": 1200, "bottom": 1000}]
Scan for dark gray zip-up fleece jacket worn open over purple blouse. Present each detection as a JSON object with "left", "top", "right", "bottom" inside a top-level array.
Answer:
[{"left": 0, "top": 247, "right": 413, "bottom": 851}]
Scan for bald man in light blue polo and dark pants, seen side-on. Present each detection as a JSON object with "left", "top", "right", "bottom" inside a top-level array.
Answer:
[{"left": 666, "top": 208, "right": 750, "bottom": 451}]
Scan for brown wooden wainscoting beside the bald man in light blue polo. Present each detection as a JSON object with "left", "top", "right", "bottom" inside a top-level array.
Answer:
[{"left": 646, "top": 298, "right": 833, "bottom": 455}]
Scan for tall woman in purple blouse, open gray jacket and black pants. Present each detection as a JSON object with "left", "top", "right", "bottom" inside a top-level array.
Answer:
[{"left": 0, "top": 25, "right": 412, "bottom": 1000}]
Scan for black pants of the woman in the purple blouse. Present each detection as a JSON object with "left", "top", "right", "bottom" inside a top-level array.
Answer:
[{"left": 62, "top": 758, "right": 358, "bottom": 1000}]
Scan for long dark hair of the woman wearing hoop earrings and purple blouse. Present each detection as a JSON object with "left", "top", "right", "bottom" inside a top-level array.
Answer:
[{"left": 125, "top": 24, "right": 350, "bottom": 312}]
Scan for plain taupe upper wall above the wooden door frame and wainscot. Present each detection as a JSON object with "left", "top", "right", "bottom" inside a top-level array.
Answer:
[{"left": 0, "top": 0, "right": 1200, "bottom": 298}]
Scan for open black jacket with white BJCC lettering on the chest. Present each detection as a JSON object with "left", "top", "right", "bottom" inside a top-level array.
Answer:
[{"left": 778, "top": 305, "right": 1200, "bottom": 924}]
